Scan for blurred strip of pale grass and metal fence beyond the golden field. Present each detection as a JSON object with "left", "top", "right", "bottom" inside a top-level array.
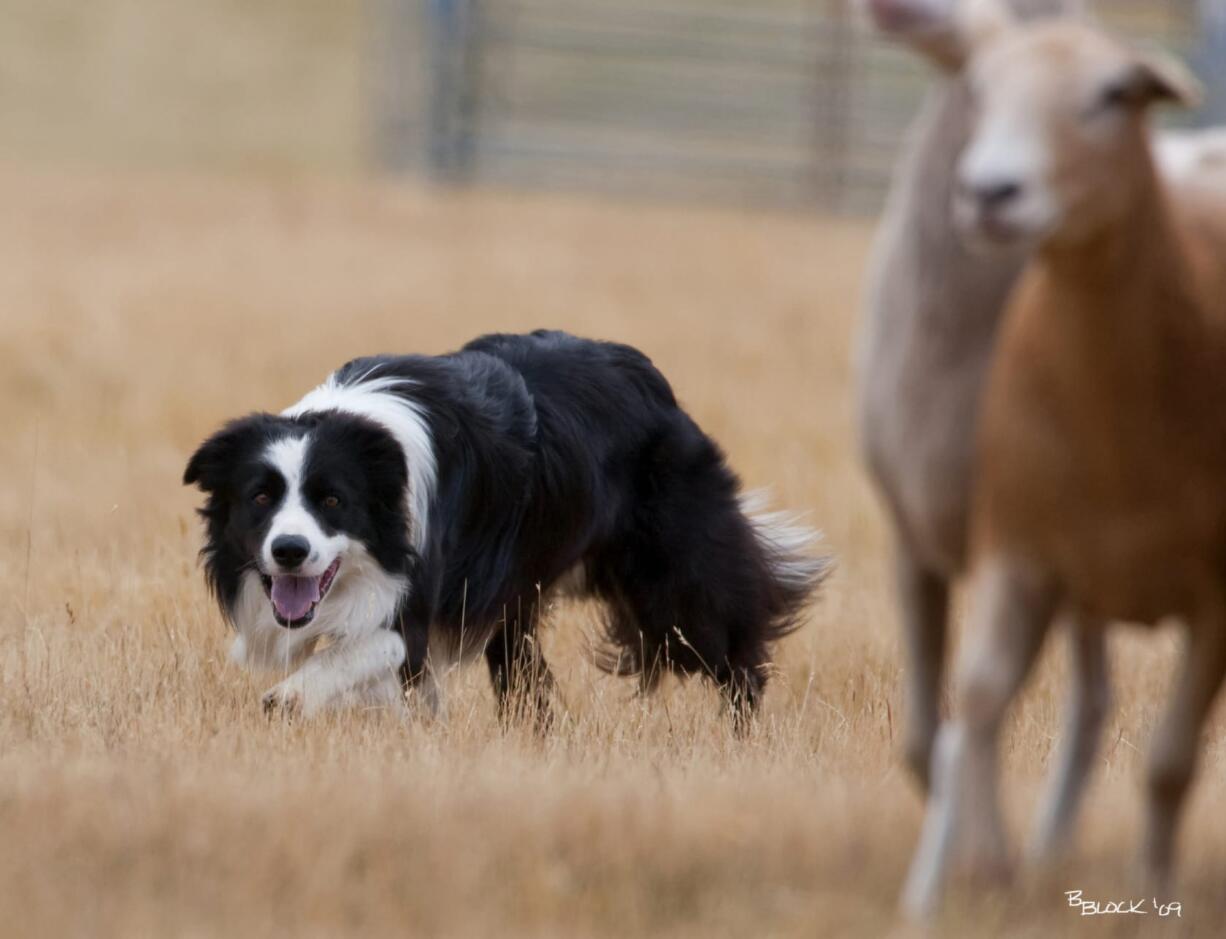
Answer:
[{"left": 0, "top": 0, "right": 1226, "bottom": 213}]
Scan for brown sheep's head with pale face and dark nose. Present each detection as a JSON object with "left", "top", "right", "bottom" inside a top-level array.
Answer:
[{"left": 954, "top": 22, "right": 1198, "bottom": 245}]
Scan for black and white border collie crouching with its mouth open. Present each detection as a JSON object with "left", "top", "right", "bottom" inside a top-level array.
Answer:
[{"left": 184, "top": 331, "right": 829, "bottom": 720}]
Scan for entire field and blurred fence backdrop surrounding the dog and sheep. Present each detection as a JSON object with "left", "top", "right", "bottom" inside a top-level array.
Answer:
[{"left": 7, "top": 0, "right": 1226, "bottom": 939}]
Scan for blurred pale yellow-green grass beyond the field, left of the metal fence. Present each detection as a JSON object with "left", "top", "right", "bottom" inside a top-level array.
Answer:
[{"left": 0, "top": 0, "right": 362, "bottom": 172}]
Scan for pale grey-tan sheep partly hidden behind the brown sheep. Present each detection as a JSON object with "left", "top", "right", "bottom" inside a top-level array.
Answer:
[{"left": 857, "top": 0, "right": 1103, "bottom": 818}]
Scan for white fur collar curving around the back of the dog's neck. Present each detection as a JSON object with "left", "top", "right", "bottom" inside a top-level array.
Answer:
[{"left": 281, "top": 374, "right": 438, "bottom": 550}]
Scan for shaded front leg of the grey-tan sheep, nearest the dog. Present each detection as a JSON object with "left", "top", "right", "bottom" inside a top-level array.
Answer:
[{"left": 897, "top": 544, "right": 949, "bottom": 792}]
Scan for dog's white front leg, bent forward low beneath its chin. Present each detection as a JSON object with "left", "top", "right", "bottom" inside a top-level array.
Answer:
[{"left": 264, "top": 629, "right": 405, "bottom": 717}]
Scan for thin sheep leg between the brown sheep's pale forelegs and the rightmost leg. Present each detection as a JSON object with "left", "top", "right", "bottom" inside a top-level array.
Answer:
[{"left": 1030, "top": 617, "right": 1111, "bottom": 864}]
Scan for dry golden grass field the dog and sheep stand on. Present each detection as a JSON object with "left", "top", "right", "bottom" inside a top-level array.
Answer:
[{"left": 0, "top": 165, "right": 1226, "bottom": 937}]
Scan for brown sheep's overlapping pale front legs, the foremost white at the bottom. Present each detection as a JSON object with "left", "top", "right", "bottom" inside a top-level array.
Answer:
[{"left": 902, "top": 561, "right": 1057, "bottom": 917}]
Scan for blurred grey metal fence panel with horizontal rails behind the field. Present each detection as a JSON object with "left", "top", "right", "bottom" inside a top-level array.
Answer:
[{"left": 379, "top": 0, "right": 1226, "bottom": 212}]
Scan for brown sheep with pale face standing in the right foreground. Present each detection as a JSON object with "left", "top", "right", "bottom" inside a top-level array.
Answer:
[{"left": 904, "top": 0, "right": 1226, "bottom": 914}]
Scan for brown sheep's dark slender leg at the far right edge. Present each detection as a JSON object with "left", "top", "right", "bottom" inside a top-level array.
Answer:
[{"left": 1141, "top": 617, "right": 1226, "bottom": 890}]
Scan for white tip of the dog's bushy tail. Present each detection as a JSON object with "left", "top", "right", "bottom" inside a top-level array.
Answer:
[{"left": 741, "top": 489, "right": 834, "bottom": 642}]
